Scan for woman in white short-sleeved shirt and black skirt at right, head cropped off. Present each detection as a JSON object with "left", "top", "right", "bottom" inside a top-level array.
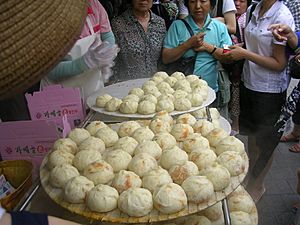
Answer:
[{"left": 226, "top": 0, "right": 295, "bottom": 201}]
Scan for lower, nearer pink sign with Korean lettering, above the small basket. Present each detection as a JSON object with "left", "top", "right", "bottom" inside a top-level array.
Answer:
[{"left": 0, "top": 120, "right": 59, "bottom": 176}]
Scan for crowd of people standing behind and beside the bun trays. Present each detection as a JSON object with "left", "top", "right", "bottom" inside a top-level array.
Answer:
[{"left": 1, "top": 0, "right": 300, "bottom": 223}]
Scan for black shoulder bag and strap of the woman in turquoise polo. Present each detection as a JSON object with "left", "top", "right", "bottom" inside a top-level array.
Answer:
[{"left": 161, "top": 19, "right": 196, "bottom": 75}]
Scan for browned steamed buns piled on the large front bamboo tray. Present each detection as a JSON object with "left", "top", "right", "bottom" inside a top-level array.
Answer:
[{"left": 46, "top": 110, "right": 247, "bottom": 217}]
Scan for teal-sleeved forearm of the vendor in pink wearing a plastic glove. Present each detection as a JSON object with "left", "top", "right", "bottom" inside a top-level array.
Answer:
[{"left": 48, "top": 57, "right": 88, "bottom": 81}]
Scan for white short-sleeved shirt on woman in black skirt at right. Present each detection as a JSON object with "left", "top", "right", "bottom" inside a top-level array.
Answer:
[{"left": 242, "top": 1, "right": 295, "bottom": 93}]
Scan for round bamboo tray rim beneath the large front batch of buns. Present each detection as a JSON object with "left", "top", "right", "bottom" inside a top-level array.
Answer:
[{"left": 40, "top": 120, "right": 249, "bottom": 223}]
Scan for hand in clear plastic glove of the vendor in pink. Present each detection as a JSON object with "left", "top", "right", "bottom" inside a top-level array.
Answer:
[{"left": 83, "top": 37, "right": 119, "bottom": 69}]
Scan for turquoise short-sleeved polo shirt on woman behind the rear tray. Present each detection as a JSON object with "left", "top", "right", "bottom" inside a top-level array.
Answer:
[{"left": 164, "top": 15, "right": 232, "bottom": 92}]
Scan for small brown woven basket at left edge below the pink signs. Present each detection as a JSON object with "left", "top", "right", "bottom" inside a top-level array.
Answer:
[{"left": 0, "top": 160, "right": 33, "bottom": 210}]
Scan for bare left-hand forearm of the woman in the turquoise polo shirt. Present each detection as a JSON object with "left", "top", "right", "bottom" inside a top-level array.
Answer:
[{"left": 162, "top": 42, "right": 191, "bottom": 64}]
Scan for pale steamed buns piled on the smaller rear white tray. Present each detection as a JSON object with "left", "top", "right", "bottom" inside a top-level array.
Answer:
[{"left": 95, "top": 72, "right": 208, "bottom": 115}]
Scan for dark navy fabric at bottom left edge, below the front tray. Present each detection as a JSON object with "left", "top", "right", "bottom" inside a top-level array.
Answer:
[{"left": 9, "top": 211, "right": 48, "bottom": 225}]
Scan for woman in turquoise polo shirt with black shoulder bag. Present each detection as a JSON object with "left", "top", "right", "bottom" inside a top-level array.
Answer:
[{"left": 162, "top": 0, "right": 232, "bottom": 117}]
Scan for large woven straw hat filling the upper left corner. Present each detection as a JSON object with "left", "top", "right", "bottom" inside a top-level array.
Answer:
[{"left": 0, "top": 0, "right": 87, "bottom": 99}]
